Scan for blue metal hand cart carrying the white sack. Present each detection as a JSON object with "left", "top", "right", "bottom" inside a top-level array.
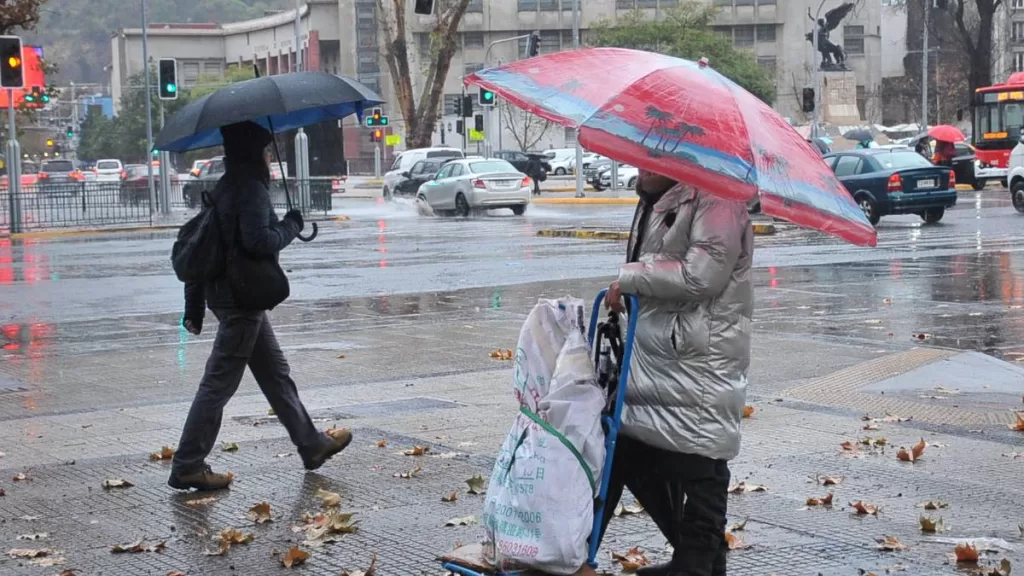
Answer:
[{"left": 441, "top": 290, "right": 639, "bottom": 576}]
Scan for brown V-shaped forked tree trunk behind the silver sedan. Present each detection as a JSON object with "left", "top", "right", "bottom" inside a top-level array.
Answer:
[{"left": 377, "top": 0, "right": 469, "bottom": 148}]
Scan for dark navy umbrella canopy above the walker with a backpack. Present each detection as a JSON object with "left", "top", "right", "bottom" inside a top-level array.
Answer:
[{"left": 154, "top": 72, "right": 384, "bottom": 152}]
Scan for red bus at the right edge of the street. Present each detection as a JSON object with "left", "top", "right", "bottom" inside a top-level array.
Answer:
[{"left": 974, "top": 72, "right": 1024, "bottom": 168}]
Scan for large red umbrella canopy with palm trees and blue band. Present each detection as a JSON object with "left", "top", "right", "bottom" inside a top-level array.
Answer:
[{"left": 466, "top": 48, "right": 876, "bottom": 246}]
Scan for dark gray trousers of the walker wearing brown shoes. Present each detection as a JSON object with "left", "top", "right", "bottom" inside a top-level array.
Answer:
[{"left": 172, "top": 310, "right": 324, "bottom": 475}]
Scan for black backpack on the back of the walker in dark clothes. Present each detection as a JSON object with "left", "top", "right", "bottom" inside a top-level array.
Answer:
[{"left": 171, "top": 192, "right": 226, "bottom": 283}]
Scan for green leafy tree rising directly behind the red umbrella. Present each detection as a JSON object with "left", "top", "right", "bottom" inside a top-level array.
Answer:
[{"left": 595, "top": 0, "right": 774, "bottom": 105}]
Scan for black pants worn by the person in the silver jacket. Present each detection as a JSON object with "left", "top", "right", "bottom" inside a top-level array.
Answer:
[{"left": 601, "top": 436, "right": 729, "bottom": 576}]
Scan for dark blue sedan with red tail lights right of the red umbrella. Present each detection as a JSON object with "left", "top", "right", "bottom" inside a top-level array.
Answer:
[{"left": 824, "top": 149, "right": 956, "bottom": 224}]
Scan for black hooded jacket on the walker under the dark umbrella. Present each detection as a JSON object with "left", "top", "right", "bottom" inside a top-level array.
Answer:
[{"left": 185, "top": 122, "right": 301, "bottom": 320}]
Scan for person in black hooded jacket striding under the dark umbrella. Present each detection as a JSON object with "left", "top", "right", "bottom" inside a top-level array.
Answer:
[{"left": 167, "top": 122, "right": 352, "bottom": 490}]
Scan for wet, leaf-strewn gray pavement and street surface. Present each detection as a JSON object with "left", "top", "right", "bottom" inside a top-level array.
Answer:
[{"left": 0, "top": 190, "right": 1024, "bottom": 576}]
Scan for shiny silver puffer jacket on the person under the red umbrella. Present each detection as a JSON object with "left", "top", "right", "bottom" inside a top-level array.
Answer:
[{"left": 618, "top": 184, "right": 754, "bottom": 460}]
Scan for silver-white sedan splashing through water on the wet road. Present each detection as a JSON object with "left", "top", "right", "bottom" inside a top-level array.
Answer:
[{"left": 417, "top": 159, "right": 534, "bottom": 216}]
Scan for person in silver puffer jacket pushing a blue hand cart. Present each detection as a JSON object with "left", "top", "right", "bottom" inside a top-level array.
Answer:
[{"left": 605, "top": 171, "right": 754, "bottom": 576}]
